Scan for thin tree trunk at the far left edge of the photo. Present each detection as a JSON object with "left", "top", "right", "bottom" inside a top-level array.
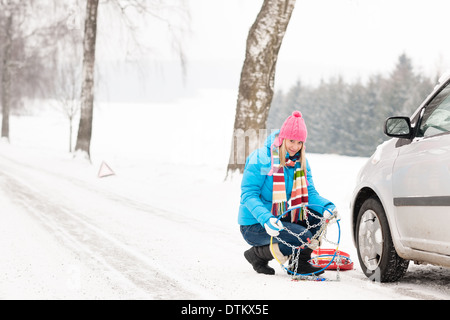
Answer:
[{"left": 1, "top": 13, "right": 13, "bottom": 141}]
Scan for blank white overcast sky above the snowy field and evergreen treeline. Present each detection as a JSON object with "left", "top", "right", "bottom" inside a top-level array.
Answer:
[{"left": 94, "top": 0, "right": 450, "bottom": 100}]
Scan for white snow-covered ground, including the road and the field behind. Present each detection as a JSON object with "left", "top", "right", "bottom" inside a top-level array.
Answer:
[{"left": 0, "top": 91, "right": 450, "bottom": 300}]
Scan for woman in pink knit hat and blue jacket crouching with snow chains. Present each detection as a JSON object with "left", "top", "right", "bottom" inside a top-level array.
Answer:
[{"left": 238, "top": 111, "right": 337, "bottom": 274}]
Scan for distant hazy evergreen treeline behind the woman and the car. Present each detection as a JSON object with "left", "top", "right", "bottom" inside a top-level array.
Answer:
[{"left": 267, "top": 54, "right": 435, "bottom": 156}]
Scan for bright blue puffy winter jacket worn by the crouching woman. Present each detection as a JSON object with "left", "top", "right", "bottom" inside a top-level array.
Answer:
[{"left": 238, "top": 131, "right": 334, "bottom": 225}]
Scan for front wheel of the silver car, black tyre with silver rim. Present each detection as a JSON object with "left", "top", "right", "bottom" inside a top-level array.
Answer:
[{"left": 356, "top": 198, "right": 409, "bottom": 282}]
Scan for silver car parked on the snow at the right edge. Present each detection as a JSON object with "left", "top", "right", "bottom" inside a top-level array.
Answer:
[{"left": 351, "top": 74, "right": 450, "bottom": 282}]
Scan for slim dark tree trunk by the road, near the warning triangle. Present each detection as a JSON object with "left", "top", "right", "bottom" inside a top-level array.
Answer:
[{"left": 75, "top": 0, "right": 99, "bottom": 158}]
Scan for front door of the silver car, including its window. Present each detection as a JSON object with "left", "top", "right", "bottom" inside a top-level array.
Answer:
[{"left": 392, "top": 84, "right": 450, "bottom": 255}]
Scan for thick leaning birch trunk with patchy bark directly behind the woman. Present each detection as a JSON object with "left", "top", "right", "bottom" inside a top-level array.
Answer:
[{"left": 227, "top": 0, "right": 296, "bottom": 175}]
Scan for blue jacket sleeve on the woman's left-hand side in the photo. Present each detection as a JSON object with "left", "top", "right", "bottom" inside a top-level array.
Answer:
[{"left": 241, "top": 153, "right": 273, "bottom": 225}]
